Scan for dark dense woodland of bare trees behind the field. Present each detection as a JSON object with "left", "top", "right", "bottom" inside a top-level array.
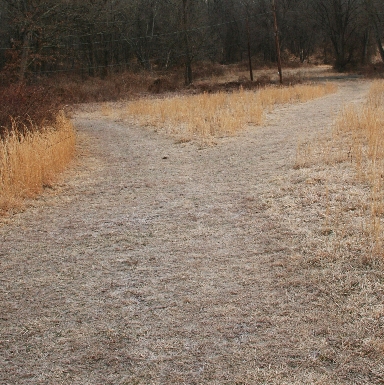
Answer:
[{"left": 0, "top": 0, "right": 384, "bottom": 83}]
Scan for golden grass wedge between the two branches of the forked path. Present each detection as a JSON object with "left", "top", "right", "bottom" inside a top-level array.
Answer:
[{"left": 126, "top": 84, "right": 336, "bottom": 138}]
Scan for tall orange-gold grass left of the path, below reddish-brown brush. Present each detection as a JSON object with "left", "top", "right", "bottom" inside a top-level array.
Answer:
[{"left": 0, "top": 113, "right": 76, "bottom": 213}]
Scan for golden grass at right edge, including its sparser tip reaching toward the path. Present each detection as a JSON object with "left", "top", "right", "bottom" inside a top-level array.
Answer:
[{"left": 304, "top": 80, "right": 384, "bottom": 255}]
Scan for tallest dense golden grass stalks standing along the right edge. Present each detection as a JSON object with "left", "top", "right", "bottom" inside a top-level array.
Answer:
[{"left": 333, "top": 80, "right": 384, "bottom": 253}]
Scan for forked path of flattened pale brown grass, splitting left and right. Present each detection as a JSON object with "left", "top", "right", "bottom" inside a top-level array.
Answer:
[{"left": 0, "top": 81, "right": 381, "bottom": 385}]
